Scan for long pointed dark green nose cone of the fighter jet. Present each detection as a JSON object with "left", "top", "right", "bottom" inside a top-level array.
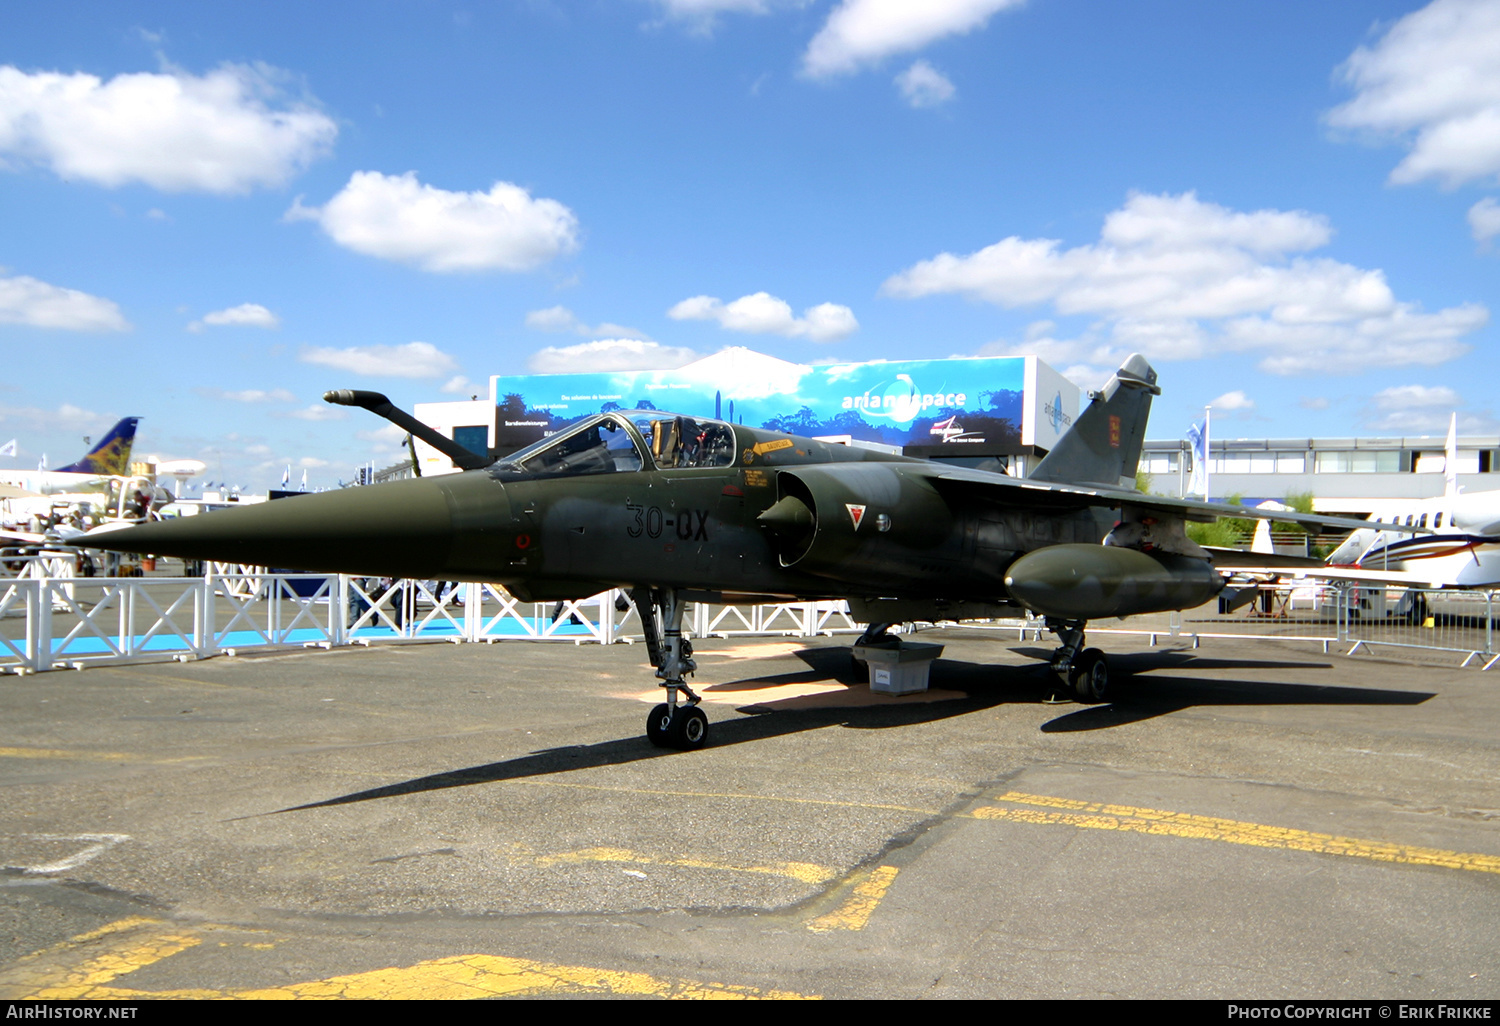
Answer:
[{"left": 90, "top": 479, "right": 468, "bottom": 578}]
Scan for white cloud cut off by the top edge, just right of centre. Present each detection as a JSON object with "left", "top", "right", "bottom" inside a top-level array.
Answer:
[{"left": 803, "top": 0, "right": 1023, "bottom": 78}]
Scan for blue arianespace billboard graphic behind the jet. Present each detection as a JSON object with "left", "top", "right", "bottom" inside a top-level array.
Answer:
[{"left": 491, "top": 350, "right": 1026, "bottom": 452}]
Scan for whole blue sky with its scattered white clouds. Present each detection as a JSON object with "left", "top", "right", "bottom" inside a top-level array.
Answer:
[{"left": 0, "top": 0, "right": 1500, "bottom": 489}]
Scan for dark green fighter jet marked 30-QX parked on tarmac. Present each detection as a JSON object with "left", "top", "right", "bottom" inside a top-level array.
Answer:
[{"left": 87, "top": 356, "right": 1410, "bottom": 749}]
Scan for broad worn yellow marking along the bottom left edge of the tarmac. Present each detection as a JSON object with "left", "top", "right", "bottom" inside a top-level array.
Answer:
[{"left": 0, "top": 918, "right": 816, "bottom": 1001}]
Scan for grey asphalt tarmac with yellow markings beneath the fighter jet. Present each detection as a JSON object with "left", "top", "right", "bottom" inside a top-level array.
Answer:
[{"left": 0, "top": 630, "right": 1500, "bottom": 1001}]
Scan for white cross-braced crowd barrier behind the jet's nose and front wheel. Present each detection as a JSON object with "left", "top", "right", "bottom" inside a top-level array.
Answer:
[{"left": 0, "top": 554, "right": 860, "bottom": 674}]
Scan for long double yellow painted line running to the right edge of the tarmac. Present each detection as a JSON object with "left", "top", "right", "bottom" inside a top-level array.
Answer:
[{"left": 971, "top": 791, "right": 1500, "bottom": 873}]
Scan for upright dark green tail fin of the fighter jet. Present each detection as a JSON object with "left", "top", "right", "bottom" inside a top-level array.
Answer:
[{"left": 1031, "top": 353, "right": 1161, "bottom": 488}]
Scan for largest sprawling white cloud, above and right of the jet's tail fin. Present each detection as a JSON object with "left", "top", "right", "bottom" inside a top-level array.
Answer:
[{"left": 882, "top": 192, "right": 1490, "bottom": 374}]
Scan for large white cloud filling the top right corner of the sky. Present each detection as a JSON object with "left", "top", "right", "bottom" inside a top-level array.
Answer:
[{"left": 1328, "top": 0, "right": 1500, "bottom": 186}]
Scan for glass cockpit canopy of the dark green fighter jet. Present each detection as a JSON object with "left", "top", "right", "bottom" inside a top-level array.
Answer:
[{"left": 491, "top": 410, "right": 735, "bottom": 477}]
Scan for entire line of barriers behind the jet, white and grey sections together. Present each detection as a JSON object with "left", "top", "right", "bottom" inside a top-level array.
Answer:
[{"left": 0, "top": 552, "right": 1500, "bottom": 672}]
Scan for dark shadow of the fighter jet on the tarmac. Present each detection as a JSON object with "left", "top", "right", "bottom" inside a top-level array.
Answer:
[{"left": 273, "top": 648, "right": 1433, "bottom": 815}]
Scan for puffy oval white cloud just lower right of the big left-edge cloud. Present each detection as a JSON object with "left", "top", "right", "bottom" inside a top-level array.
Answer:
[{"left": 287, "top": 171, "right": 578, "bottom": 272}]
